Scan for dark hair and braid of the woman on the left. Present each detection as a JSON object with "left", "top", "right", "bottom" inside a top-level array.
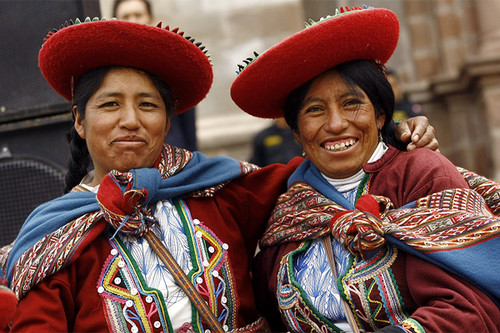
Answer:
[{"left": 64, "top": 67, "right": 175, "bottom": 193}]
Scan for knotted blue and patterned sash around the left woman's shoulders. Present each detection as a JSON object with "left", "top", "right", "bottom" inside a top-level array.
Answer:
[{"left": 6, "top": 145, "right": 257, "bottom": 297}]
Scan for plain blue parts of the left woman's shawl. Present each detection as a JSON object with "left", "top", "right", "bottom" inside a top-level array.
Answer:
[{"left": 5, "top": 152, "right": 250, "bottom": 284}]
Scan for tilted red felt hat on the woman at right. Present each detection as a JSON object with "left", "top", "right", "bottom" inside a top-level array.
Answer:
[{"left": 231, "top": 6, "right": 399, "bottom": 118}]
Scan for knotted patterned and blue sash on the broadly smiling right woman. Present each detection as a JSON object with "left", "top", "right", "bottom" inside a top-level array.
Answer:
[{"left": 261, "top": 160, "right": 500, "bottom": 306}]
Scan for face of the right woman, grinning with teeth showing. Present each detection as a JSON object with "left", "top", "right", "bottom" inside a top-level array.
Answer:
[{"left": 294, "top": 71, "right": 385, "bottom": 179}]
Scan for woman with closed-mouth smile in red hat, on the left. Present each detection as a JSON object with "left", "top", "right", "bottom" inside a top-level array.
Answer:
[{"left": 0, "top": 13, "right": 472, "bottom": 332}]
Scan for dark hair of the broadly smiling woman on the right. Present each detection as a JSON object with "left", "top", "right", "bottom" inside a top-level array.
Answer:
[{"left": 284, "top": 60, "right": 405, "bottom": 150}]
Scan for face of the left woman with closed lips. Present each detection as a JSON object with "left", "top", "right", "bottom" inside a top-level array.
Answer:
[{"left": 73, "top": 68, "right": 170, "bottom": 185}]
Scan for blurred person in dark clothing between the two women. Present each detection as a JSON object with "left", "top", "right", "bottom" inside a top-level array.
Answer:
[{"left": 250, "top": 118, "right": 302, "bottom": 167}]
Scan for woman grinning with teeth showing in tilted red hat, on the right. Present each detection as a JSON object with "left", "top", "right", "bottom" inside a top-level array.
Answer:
[{"left": 231, "top": 7, "right": 500, "bottom": 332}]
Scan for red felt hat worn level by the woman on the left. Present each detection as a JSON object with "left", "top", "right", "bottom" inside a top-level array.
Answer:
[{"left": 38, "top": 19, "right": 213, "bottom": 113}]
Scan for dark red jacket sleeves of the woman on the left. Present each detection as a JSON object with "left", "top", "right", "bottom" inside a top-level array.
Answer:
[{"left": 9, "top": 158, "right": 302, "bottom": 332}]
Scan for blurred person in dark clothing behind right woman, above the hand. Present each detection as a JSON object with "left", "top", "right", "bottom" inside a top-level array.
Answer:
[{"left": 385, "top": 69, "right": 422, "bottom": 122}]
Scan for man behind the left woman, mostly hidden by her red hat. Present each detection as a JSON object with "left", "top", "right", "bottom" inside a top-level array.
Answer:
[{"left": 113, "top": 0, "right": 198, "bottom": 151}]
